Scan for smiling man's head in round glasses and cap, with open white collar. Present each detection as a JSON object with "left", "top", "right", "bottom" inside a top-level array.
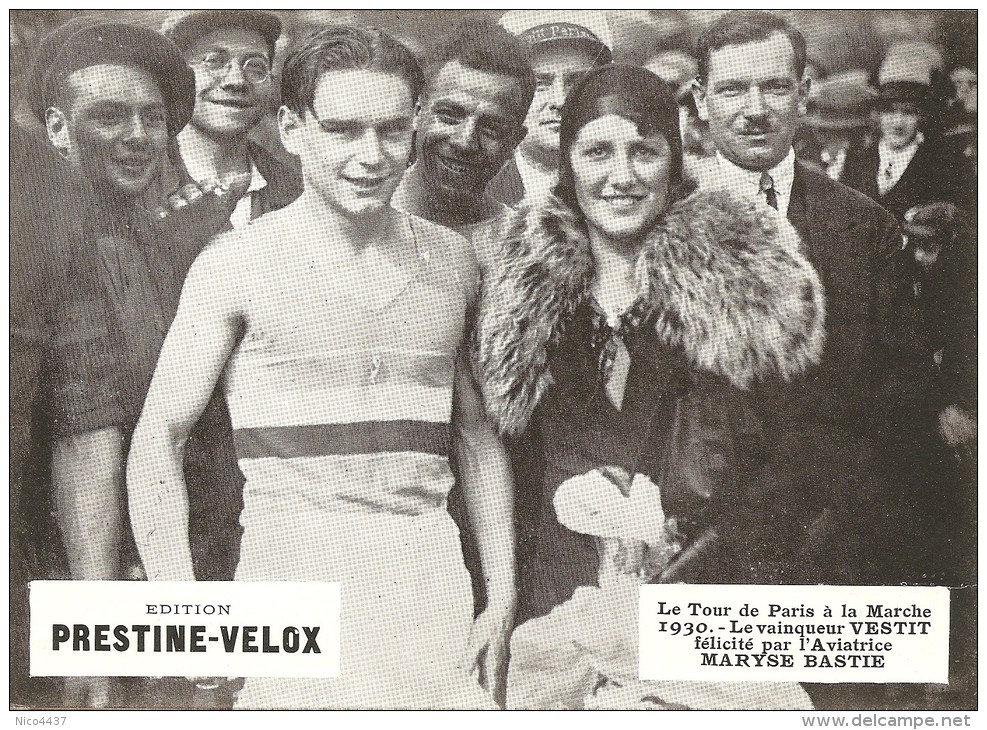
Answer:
[{"left": 163, "top": 10, "right": 301, "bottom": 228}]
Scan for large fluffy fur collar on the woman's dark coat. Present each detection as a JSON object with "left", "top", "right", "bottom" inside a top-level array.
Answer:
[{"left": 477, "top": 191, "right": 825, "bottom": 434}]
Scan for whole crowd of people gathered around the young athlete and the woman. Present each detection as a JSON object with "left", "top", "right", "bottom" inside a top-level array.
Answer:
[{"left": 10, "top": 10, "right": 977, "bottom": 709}]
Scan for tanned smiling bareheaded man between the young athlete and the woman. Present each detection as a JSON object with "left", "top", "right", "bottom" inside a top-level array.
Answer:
[{"left": 392, "top": 19, "right": 535, "bottom": 238}]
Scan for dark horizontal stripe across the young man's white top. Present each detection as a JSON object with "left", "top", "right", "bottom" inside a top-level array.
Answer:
[{"left": 233, "top": 421, "right": 452, "bottom": 459}]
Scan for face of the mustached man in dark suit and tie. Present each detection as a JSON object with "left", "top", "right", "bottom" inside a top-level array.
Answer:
[{"left": 695, "top": 32, "right": 808, "bottom": 171}]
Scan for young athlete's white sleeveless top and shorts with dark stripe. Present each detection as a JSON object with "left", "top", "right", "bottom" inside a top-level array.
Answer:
[{"left": 147, "top": 210, "right": 502, "bottom": 709}]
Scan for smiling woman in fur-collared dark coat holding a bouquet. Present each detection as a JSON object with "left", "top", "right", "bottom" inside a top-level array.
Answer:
[{"left": 478, "top": 65, "right": 823, "bottom": 709}]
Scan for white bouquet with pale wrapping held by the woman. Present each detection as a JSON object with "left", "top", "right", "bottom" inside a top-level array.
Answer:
[{"left": 507, "top": 467, "right": 812, "bottom": 709}]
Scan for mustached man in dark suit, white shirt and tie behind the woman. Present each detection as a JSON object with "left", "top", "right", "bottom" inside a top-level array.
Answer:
[{"left": 694, "top": 11, "right": 920, "bottom": 583}]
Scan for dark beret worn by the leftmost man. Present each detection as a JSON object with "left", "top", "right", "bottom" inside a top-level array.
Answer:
[{"left": 26, "top": 16, "right": 195, "bottom": 136}]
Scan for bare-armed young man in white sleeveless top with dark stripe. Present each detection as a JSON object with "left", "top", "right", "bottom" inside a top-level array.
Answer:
[{"left": 127, "top": 26, "right": 515, "bottom": 708}]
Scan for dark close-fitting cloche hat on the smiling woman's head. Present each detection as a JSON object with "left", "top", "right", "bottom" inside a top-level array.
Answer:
[{"left": 553, "top": 63, "right": 686, "bottom": 211}]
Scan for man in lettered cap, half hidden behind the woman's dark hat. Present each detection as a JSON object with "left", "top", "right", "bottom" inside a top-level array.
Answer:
[{"left": 487, "top": 10, "right": 613, "bottom": 206}]
